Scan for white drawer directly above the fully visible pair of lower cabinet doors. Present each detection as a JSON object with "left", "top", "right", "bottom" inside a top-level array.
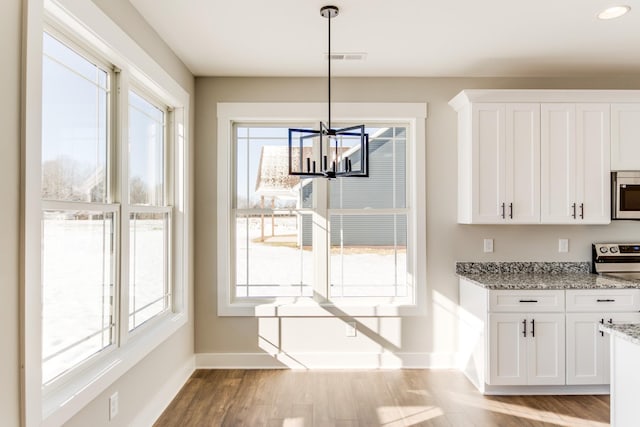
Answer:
[{"left": 489, "top": 290, "right": 564, "bottom": 313}]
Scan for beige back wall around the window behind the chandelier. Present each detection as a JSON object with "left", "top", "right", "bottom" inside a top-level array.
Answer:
[{"left": 195, "top": 77, "right": 640, "bottom": 361}]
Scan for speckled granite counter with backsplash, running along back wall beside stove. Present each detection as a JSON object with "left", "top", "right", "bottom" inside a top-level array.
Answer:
[{"left": 456, "top": 262, "right": 640, "bottom": 289}]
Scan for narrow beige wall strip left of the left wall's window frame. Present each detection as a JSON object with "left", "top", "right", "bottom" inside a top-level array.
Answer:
[{"left": 0, "top": 0, "right": 22, "bottom": 426}]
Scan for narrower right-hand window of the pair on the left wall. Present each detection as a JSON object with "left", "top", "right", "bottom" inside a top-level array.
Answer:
[{"left": 125, "top": 90, "right": 171, "bottom": 330}]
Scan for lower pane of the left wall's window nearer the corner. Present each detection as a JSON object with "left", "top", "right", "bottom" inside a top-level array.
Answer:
[{"left": 129, "top": 213, "right": 169, "bottom": 330}]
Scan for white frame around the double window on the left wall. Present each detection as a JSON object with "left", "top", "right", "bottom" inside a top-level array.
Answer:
[{"left": 21, "top": 0, "right": 192, "bottom": 426}]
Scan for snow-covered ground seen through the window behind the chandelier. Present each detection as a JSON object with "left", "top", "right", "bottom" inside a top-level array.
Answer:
[{"left": 236, "top": 216, "right": 407, "bottom": 297}]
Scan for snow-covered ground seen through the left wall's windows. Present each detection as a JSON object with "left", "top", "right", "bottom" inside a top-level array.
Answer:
[{"left": 42, "top": 217, "right": 164, "bottom": 382}]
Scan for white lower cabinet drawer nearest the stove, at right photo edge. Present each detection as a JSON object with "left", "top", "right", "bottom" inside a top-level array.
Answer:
[{"left": 567, "top": 289, "right": 640, "bottom": 312}]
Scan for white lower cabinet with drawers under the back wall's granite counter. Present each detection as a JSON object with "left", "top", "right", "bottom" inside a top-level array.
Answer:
[{"left": 459, "top": 279, "right": 640, "bottom": 394}]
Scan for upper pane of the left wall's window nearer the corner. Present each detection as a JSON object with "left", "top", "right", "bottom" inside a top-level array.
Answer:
[{"left": 129, "top": 91, "right": 165, "bottom": 206}]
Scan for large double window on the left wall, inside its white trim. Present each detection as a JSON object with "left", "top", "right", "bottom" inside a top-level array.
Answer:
[{"left": 41, "top": 25, "right": 182, "bottom": 394}]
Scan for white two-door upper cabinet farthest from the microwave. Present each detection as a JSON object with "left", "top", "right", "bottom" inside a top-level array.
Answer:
[{"left": 458, "top": 103, "right": 540, "bottom": 224}]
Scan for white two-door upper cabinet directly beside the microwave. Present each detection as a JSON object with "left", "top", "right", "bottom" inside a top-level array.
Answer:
[{"left": 541, "top": 103, "right": 611, "bottom": 224}]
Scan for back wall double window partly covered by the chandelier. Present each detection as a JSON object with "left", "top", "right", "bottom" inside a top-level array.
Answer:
[{"left": 218, "top": 104, "right": 425, "bottom": 315}]
